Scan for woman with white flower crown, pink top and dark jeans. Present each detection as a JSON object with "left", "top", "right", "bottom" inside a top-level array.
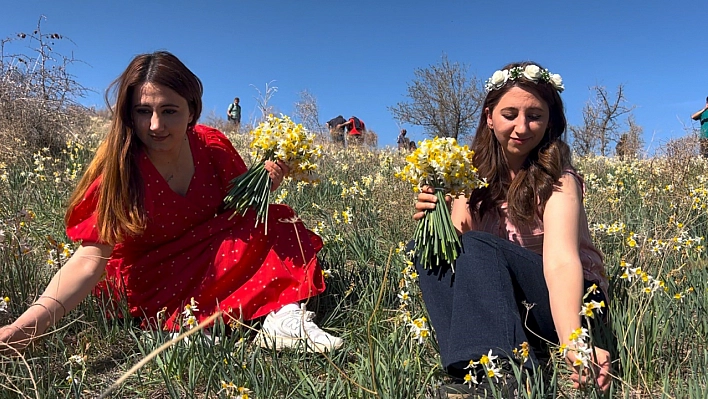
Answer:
[{"left": 414, "top": 62, "right": 610, "bottom": 398}]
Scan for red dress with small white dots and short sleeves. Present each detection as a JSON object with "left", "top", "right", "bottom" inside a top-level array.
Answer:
[{"left": 66, "top": 125, "right": 325, "bottom": 328}]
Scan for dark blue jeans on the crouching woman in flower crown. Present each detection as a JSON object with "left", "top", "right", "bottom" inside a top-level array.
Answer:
[{"left": 416, "top": 231, "right": 590, "bottom": 374}]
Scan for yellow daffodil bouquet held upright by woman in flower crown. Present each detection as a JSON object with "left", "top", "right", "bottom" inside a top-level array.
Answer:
[{"left": 396, "top": 137, "right": 486, "bottom": 272}]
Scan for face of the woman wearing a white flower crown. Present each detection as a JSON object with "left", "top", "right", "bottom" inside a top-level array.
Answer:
[{"left": 484, "top": 87, "right": 549, "bottom": 173}]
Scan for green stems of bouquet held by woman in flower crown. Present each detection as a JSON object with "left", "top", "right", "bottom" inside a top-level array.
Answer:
[{"left": 413, "top": 189, "right": 462, "bottom": 273}]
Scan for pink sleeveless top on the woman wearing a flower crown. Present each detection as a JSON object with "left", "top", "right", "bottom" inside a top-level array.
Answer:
[{"left": 473, "top": 170, "right": 609, "bottom": 298}]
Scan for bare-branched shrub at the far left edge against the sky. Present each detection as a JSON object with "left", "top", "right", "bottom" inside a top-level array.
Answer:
[{"left": 0, "top": 16, "right": 90, "bottom": 161}]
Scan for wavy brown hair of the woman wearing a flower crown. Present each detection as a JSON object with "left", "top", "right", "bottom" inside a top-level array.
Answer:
[{"left": 469, "top": 62, "right": 572, "bottom": 224}]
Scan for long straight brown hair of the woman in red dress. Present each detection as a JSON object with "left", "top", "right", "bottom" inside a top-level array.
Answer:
[{"left": 64, "top": 51, "right": 203, "bottom": 245}]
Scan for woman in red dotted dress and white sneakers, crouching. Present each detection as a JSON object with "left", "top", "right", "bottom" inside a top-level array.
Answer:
[{"left": 0, "top": 52, "right": 342, "bottom": 352}]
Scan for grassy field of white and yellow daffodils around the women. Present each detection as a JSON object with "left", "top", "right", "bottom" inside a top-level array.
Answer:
[{"left": 0, "top": 122, "right": 708, "bottom": 399}]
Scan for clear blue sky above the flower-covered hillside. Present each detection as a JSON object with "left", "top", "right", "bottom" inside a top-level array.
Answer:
[{"left": 0, "top": 0, "right": 708, "bottom": 151}]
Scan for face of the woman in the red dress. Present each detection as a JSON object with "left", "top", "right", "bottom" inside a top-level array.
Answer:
[{"left": 131, "top": 83, "right": 194, "bottom": 157}]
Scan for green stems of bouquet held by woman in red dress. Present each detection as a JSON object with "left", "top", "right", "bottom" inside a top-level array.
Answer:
[{"left": 224, "top": 159, "right": 273, "bottom": 234}]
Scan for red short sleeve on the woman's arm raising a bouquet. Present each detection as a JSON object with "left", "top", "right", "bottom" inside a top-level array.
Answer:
[{"left": 195, "top": 125, "right": 248, "bottom": 191}]
